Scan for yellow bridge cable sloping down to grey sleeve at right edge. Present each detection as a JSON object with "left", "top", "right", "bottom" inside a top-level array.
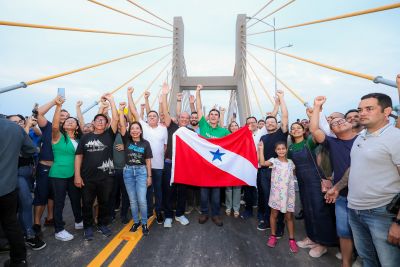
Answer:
[{"left": 248, "top": 43, "right": 397, "bottom": 88}]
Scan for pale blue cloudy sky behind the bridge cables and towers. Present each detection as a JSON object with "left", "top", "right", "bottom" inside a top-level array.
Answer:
[{"left": 0, "top": 0, "right": 400, "bottom": 121}]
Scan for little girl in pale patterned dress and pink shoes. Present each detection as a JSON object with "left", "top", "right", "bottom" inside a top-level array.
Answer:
[{"left": 258, "top": 142, "right": 299, "bottom": 253}]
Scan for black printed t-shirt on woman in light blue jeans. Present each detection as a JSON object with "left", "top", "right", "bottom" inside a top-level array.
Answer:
[{"left": 122, "top": 133, "right": 153, "bottom": 166}]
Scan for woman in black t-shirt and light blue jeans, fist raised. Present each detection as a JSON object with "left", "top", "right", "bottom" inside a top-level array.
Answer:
[{"left": 120, "top": 119, "right": 153, "bottom": 235}]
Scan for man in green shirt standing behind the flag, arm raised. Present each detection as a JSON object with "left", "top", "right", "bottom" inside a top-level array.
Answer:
[{"left": 196, "top": 84, "right": 230, "bottom": 226}]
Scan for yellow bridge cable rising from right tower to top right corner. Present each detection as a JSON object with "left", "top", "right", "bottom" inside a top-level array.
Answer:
[{"left": 247, "top": 3, "right": 400, "bottom": 36}]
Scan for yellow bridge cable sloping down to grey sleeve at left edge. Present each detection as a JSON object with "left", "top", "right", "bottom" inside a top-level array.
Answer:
[{"left": 0, "top": 44, "right": 171, "bottom": 94}]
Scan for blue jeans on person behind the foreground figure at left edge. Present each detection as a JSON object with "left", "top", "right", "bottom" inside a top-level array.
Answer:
[{"left": 18, "top": 166, "right": 35, "bottom": 238}]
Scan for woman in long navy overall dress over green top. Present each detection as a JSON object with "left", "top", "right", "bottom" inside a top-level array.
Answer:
[{"left": 288, "top": 122, "right": 337, "bottom": 258}]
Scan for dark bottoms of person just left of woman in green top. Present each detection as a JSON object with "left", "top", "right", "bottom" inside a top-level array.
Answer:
[{"left": 33, "top": 163, "right": 54, "bottom": 206}]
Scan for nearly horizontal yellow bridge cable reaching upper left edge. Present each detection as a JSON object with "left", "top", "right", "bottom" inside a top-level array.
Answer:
[{"left": 0, "top": 20, "right": 172, "bottom": 38}]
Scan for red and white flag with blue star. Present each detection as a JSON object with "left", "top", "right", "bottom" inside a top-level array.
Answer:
[{"left": 171, "top": 127, "right": 258, "bottom": 187}]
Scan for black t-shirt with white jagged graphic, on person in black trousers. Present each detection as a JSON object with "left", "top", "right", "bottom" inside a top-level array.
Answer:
[{"left": 75, "top": 127, "right": 115, "bottom": 180}]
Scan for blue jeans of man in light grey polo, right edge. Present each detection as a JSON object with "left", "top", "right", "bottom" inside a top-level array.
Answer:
[{"left": 349, "top": 205, "right": 400, "bottom": 267}]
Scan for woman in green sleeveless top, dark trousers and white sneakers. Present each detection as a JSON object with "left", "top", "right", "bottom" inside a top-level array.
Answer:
[{"left": 49, "top": 96, "right": 83, "bottom": 241}]
